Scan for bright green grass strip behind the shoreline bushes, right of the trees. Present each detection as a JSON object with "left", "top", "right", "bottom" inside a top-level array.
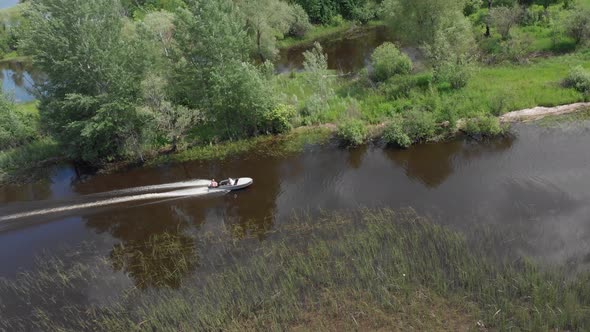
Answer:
[{"left": 276, "top": 52, "right": 590, "bottom": 139}]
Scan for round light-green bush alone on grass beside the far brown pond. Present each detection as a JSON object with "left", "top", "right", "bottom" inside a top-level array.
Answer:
[{"left": 371, "top": 42, "right": 412, "bottom": 82}]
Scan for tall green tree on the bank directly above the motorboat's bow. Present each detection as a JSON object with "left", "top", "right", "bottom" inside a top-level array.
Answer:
[{"left": 172, "top": 0, "right": 275, "bottom": 138}]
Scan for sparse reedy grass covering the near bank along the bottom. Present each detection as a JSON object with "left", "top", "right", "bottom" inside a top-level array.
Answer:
[{"left": 0, "top": 210, "right": 590, "bottom": 331}]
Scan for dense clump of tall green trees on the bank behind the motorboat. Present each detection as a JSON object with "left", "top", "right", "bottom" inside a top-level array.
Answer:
[{"left": 22, "top": 0, "right": 320, "bottom": 163}]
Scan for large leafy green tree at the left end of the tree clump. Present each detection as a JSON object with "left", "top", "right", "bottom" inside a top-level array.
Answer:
[{"left": 22, "top": 0, "right": 150, "bottom": 163}]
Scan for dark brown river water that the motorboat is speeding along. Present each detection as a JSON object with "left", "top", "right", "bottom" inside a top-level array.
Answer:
[{"left": 0, "top": 120, "right": 590, "bottom": 278}]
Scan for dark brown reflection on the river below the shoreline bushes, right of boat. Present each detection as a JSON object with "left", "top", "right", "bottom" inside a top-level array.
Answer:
[{"left": 386, "top": 137, "right": 513, "bottom": 188}]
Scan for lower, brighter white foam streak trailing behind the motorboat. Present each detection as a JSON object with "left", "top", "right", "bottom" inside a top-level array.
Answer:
[{"left": 0, "top": 187, "right": 229, "bottom": 222}]
